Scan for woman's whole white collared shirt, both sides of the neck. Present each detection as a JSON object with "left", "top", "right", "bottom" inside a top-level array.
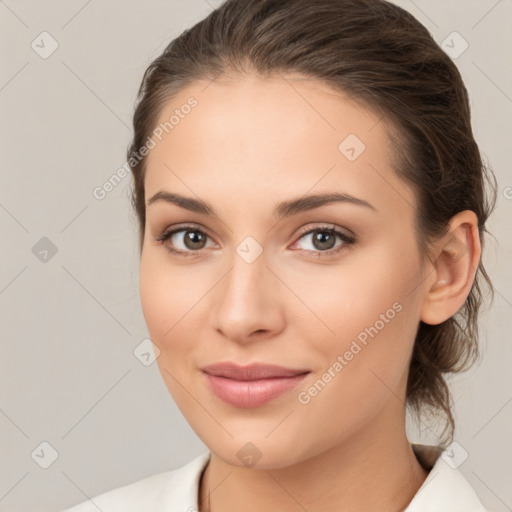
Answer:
[{"left": 62, "top": 443, "right": 488, "bottom": 512}]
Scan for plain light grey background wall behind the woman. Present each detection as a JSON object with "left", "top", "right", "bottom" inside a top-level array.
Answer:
[{"left": 0, "top": 0, "right": 512, "bottom": 512}]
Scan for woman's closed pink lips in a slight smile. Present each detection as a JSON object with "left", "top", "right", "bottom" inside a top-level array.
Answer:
[{"left": 202, "top": 362, "right": 309, "bottom": 408}]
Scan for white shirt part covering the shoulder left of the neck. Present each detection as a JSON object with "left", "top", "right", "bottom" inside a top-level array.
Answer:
[{"left": 62, "top": 452, "right": 210, "bottom": 512}]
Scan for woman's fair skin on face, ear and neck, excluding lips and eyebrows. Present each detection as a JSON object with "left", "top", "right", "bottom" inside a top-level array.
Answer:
[{"left": 140, "top": 75, "right": 481, "bottom": 512}]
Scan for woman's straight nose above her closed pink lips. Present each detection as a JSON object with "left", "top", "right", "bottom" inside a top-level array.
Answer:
[{"left": 210, "top": 247, "right": 284, "bottom": 344}]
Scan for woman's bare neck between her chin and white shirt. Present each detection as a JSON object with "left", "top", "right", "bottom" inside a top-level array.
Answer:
[{"left": 198, "top": 404, "right": 428, "bottom": 512}]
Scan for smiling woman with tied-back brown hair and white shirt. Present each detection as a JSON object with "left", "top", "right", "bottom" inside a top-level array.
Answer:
[{"left": 61, "top": 0, "right": 495, "bottom": 512}]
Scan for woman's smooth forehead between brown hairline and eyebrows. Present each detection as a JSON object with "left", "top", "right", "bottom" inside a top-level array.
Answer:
[{"left": 145, "top": 70, "right": 414, "bottom": 218}]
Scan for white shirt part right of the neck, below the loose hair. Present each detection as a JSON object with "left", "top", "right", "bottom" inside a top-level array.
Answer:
[{"left": 404, "top": 444, "right": 489, "bottom": 512}]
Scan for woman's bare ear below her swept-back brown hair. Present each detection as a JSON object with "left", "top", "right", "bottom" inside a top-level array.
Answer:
[{"left": 421, "top": 210, "right": 482, "bottom": 325}]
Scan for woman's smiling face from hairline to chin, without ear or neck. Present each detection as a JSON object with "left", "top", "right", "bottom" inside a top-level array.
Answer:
[{"left": 140, "top": 75, "right": 428, "bottom": 468}]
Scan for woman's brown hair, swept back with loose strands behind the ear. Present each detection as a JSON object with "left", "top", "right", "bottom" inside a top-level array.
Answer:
[{"left": 127, "top": 0, "right": 496, "bottom": 445}]
